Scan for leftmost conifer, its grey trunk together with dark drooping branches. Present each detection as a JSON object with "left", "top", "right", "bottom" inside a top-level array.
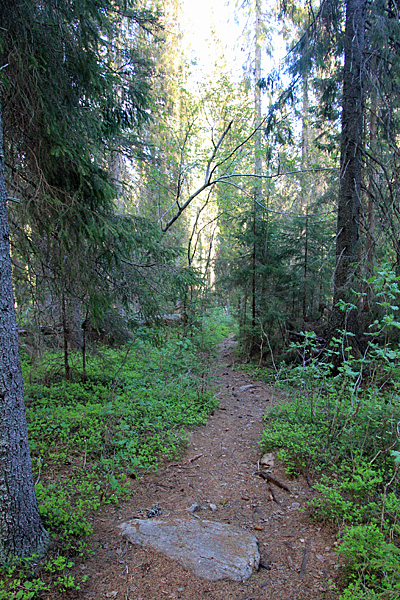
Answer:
[{"left": 0, "top": 0, "right": 165, "bottom": 563}]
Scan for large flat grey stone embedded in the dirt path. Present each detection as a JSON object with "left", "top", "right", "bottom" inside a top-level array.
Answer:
[{"left": 119, "top": 518, "right": 260, "bottom": 581}]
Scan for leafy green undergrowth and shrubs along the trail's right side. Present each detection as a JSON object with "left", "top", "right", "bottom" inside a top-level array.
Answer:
[{"left": 261, "top": 270, "right": 400, "bottom": 600}]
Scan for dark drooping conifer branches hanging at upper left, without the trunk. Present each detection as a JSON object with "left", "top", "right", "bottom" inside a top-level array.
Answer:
[{"left": 0, "top": 0, "right": 169, "bottom": 352}]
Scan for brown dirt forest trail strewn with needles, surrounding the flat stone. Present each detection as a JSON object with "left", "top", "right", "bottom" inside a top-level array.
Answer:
[{"left": 79, "top": 336, "right": 340, "bottom": 600}]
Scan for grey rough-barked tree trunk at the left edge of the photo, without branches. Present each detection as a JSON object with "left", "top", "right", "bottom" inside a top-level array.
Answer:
[{"left": 0, "top": 102, "right": 48, "bottom": 564}]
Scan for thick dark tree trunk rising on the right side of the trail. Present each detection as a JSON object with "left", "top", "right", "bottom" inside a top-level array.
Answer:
[{"left": 329, "top": 0, "right": 366, "bottom": 357}]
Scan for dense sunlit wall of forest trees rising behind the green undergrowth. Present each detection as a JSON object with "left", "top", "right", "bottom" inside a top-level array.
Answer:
[{"left": 1, "top": 2, "right": 399, "bottom": 358}]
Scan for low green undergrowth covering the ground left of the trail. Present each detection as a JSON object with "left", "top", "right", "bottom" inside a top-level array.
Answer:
[{"left": 0, "top": 309, "right": 233, "bottom": 600}]
